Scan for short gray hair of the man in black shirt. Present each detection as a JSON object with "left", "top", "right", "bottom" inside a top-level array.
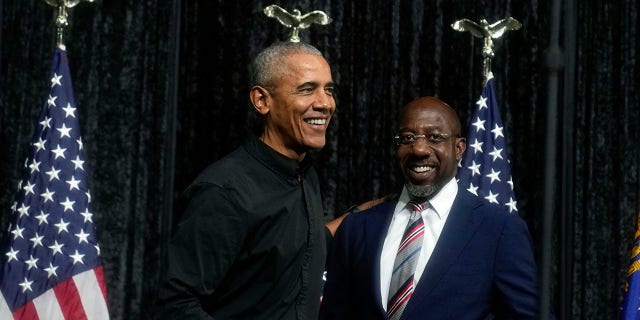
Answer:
[{"left": 251, "top": 42, "right": 322, "bottom": 90}]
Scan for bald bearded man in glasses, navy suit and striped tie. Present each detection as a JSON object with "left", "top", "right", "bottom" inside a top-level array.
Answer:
[{"left": 320, "top": 97, "right": 539, "bottom": 320}]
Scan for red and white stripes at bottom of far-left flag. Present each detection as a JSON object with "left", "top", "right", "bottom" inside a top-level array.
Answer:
[{"left": 0, "top": 267, "right": 109, "bottom": 320}]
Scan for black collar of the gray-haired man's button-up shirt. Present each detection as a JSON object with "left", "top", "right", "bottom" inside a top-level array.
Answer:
[{"left": 245, "top": 135, "right": 313, "bottom": 179}]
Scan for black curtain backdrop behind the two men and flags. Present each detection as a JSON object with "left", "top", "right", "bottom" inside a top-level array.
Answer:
[{"left": 0, "top": 0, "right": 640, "bottom": 319}]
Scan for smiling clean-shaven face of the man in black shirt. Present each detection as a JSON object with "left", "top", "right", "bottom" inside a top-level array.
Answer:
[{"left": 251, "top": 53, "right": 336, "bottom": 161}]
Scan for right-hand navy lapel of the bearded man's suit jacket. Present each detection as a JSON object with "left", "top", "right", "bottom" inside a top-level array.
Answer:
[{"left": 407, "top": 191, "right": 480, "bottom": 309}]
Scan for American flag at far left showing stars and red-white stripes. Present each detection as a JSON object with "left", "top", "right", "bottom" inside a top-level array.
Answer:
[{"left": 0, "top": 48, "right": 109, "bottom": 319}]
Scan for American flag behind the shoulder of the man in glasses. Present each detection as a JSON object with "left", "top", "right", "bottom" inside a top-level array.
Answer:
[{"left": 456, "top": 78, "right": 518, "bottom": 213}]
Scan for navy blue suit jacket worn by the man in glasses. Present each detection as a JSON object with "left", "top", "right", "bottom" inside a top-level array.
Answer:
[{"left": 320, "top": 191, "right": 539, "bottom": 320}]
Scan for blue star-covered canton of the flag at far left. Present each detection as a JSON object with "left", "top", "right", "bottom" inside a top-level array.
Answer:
[{"left": 0, "top": 49, "right": 100, "bottom": 310}]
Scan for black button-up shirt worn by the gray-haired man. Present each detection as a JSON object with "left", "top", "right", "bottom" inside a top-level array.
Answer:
[{"left": 159, "top": 137, "right": 326, "bottom": 319}]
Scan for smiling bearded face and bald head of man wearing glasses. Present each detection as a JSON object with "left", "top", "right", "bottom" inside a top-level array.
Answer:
[{"left": 396, "top": 97, "right": 466, "bottom": 199}]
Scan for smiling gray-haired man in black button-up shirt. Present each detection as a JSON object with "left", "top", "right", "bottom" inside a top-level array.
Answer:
[{"left": 159, "top": 42, "right": 336, "bottom": 319}]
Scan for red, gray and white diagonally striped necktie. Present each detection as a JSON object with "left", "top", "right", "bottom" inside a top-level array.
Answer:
[{"left": 387, "top": 201, "right": 424, "bottom": 320}]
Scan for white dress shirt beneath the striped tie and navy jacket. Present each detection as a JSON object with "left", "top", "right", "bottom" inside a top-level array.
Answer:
[{"left": 380, "top": 178, "right": 458, "bottom": 310}]
